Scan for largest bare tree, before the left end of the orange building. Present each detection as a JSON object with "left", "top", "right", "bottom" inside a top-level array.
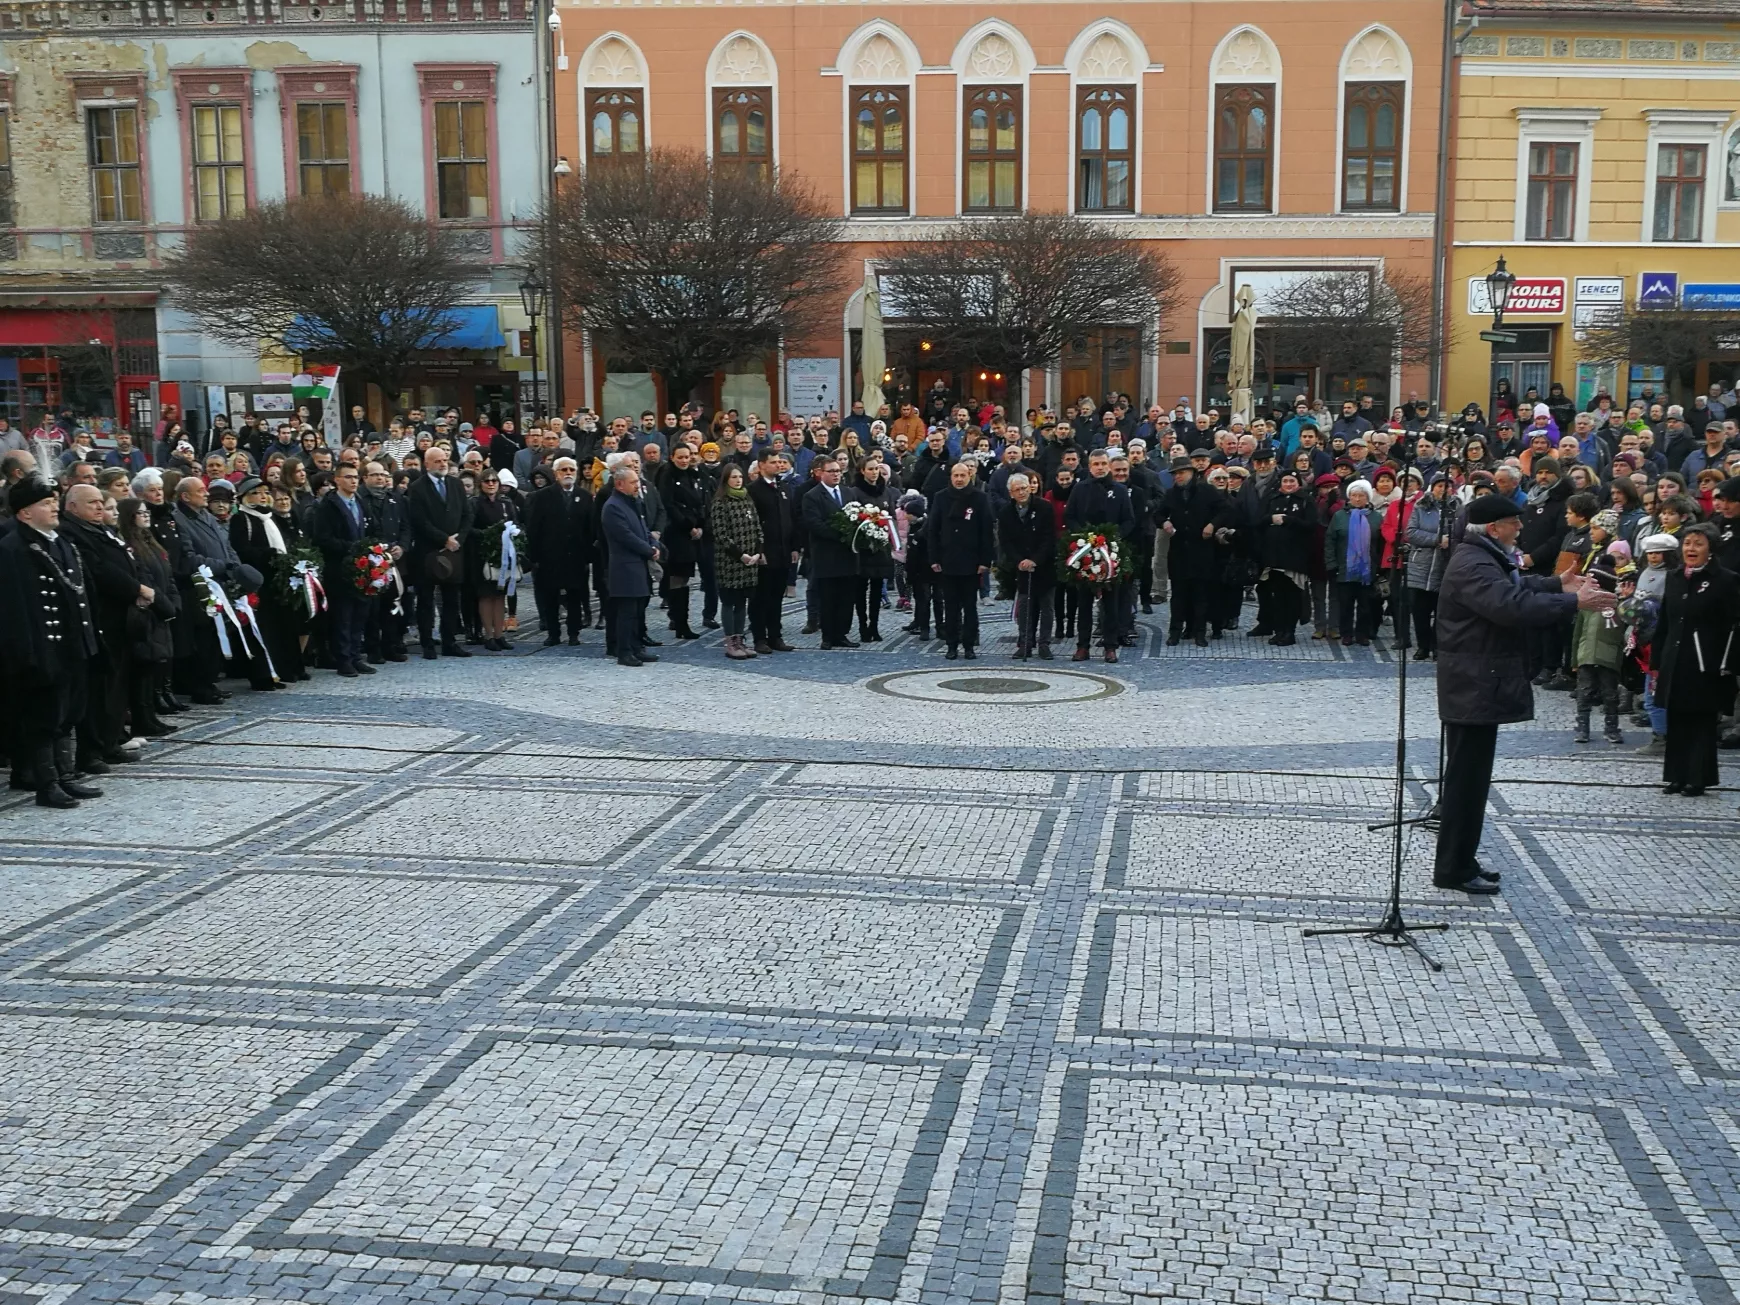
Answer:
[{"left": 545, "top": 150, "right": 840, "bottom": 404}]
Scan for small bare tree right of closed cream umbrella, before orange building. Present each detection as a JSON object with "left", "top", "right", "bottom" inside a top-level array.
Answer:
[{"left": 1256, "top": 271, "right": 1451, "bottom": 381}]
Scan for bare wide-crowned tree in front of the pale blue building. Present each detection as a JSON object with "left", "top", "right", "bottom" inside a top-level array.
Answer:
[{"left": 164, "top": 195, "right": 482, "bottom": 393}]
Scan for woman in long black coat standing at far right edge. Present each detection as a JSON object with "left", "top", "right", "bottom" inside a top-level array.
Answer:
[{"left": 1650, "top": 525, "right": 1740, "bottom": 797}]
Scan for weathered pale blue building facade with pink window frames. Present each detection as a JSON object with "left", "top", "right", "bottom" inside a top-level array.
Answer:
[{"left": 0, "top": 0, "right": 543, "bottom": 440}]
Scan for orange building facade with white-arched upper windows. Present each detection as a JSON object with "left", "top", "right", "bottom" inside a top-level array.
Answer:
[{"left": 552, "top": 0, "right": 1444, "bottom": 424}]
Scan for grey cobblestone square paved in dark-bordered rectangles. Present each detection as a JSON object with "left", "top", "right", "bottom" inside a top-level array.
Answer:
[{"left": 0, "top": 607, "right": 1740, "bottom": 1305}]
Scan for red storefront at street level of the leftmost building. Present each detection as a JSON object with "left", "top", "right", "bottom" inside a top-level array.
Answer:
[{"left": 0, "top": 294, "right": 157, "bottom": 428}]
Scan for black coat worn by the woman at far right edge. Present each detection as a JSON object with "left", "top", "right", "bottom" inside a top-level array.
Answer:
[{"left": 1650, "top": 562, "right": 1740, "bottom": 713}]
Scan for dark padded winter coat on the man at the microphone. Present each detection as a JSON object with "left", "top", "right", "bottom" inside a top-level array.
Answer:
[{"left": 1437, "top": 534, "right": 1576, "bottom": 726}]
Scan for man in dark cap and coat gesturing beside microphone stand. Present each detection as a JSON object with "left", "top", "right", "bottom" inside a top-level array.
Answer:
[{"left": 1432, "top": 494, "right": 1616, "bottom": 896}]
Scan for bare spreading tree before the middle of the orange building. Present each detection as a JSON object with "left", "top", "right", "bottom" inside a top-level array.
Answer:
[{"left": 879, "top": 212, "right": 1180, "bottom": 410}]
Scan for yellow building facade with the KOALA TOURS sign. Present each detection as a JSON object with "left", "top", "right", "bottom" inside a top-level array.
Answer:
[{"left": 1442, "top": 0, "right": 1740, "bottom": 412}]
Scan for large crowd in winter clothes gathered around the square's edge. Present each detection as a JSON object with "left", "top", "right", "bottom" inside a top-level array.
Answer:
[{"left": 0, "top": 375, "right": 1740, "bottom": 807}]
